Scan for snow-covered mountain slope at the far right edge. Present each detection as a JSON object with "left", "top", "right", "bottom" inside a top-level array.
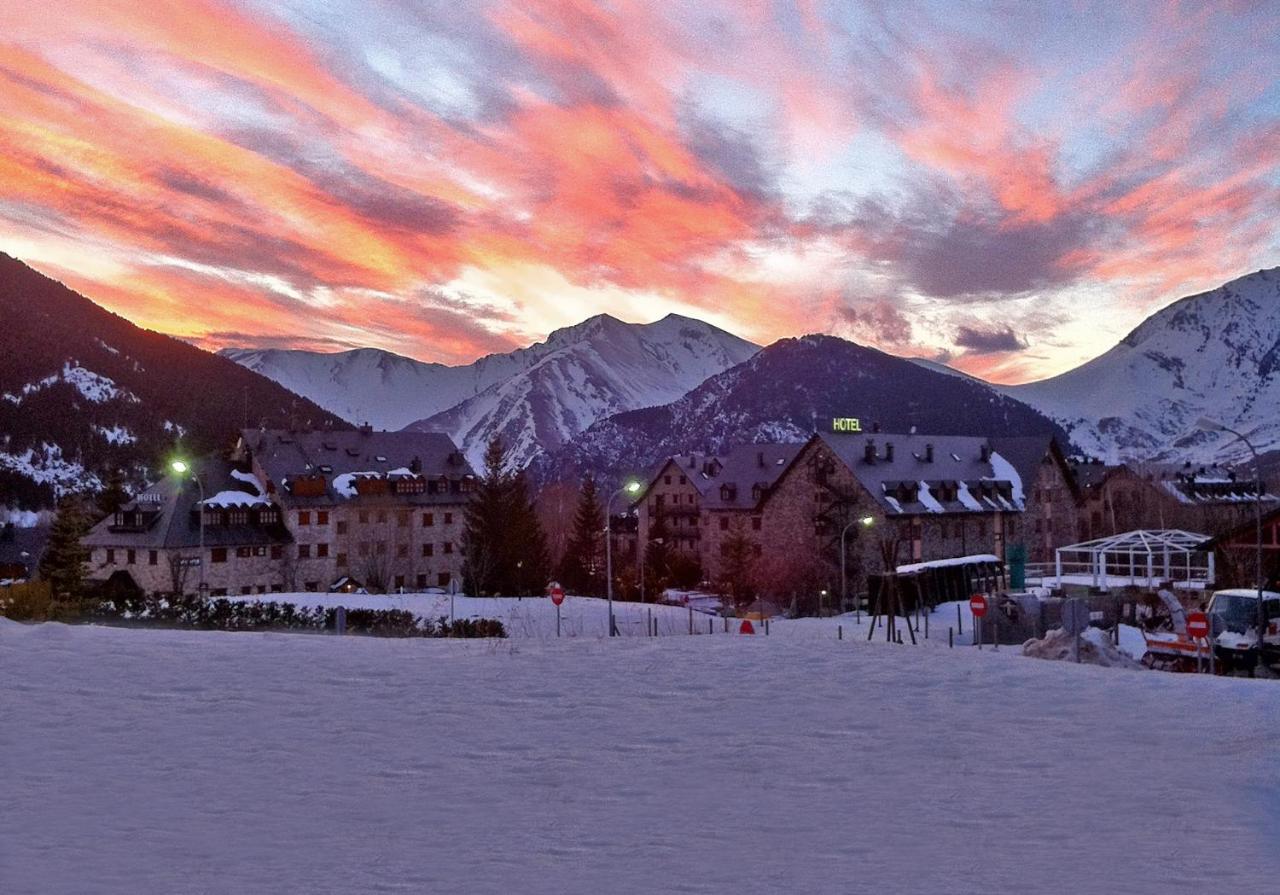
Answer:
[{"left": 997, "top": 268, "right": 1280, "bottom": 460}]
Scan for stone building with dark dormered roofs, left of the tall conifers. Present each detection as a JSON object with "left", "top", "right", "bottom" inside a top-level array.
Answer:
[{"left": 86, "top": 428, "right": 475, "bottom": 597}]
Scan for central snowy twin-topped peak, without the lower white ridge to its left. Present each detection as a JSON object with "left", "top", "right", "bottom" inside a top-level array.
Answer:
[{"left": 410, "top": 314, "right": 758, "bottom": 469}]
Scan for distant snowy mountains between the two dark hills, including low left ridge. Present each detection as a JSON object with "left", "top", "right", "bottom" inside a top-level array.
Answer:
[{"left": 220, "top": 314, "right": 759, "bottom": 467}]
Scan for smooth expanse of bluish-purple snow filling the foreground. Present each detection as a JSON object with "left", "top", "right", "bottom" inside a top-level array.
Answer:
[{"left": 0, "top": 620, "right": 1280, "bottom": 895}]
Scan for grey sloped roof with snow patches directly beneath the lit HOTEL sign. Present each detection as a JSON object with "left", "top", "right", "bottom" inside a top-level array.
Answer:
[{"left": 818, "top": 433, "right": 1023, "bottom": 516}]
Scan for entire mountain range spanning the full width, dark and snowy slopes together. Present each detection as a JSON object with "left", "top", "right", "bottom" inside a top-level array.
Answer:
[{"left": 0, "top": 255, "right": 1280, "bottom": 506}]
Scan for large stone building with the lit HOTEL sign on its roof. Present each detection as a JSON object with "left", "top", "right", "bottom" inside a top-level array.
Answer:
[{"left": 637, "top": 431, "right": 1024, "bottom": 598}]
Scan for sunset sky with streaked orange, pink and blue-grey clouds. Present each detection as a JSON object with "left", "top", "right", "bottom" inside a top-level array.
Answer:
[{"left": 0, "top": 0, "right": 1280, "bottom": 382}]
